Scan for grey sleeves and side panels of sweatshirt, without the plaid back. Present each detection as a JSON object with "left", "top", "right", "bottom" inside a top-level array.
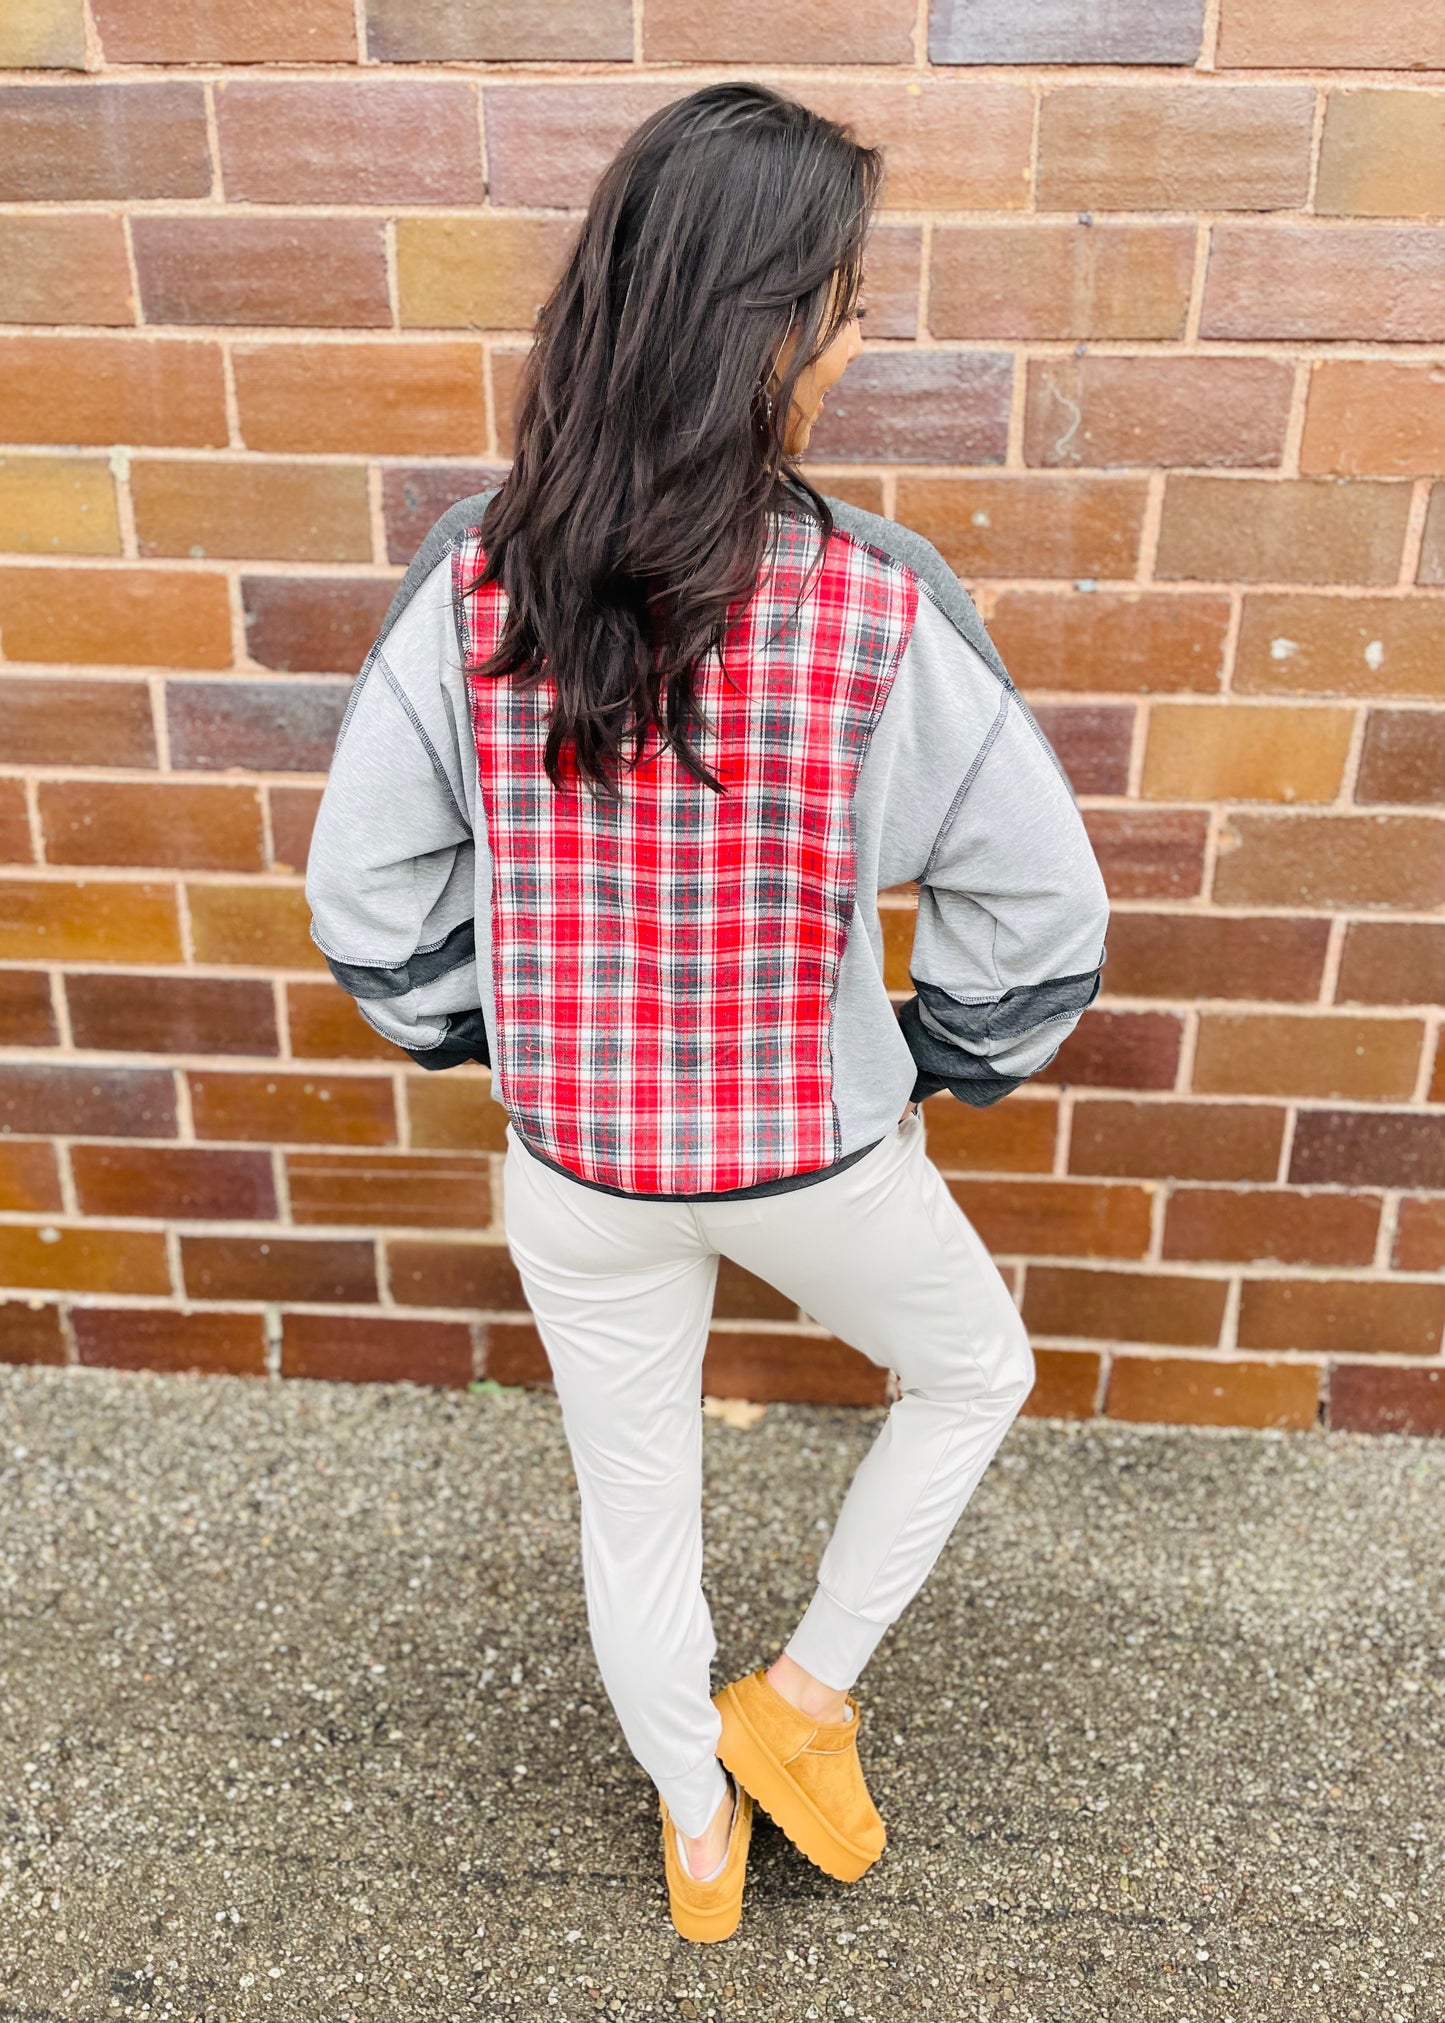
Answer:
[{"left": 306, "top": 481, "right": 1109, "bottom": 1196}]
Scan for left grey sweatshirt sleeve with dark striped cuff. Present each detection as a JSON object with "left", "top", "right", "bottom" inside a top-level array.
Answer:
[{"left": 306, "top": 556, "right": 490, "bottom": 1068}]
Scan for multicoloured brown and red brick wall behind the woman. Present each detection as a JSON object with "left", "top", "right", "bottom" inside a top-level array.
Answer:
[{"left": 0, "top": 0, "right": 1445, "bottom": 1430}]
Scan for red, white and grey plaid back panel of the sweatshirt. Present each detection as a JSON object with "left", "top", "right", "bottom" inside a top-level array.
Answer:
[{"left": 453, "top": 514, "right": 917, "bottom": 1194}]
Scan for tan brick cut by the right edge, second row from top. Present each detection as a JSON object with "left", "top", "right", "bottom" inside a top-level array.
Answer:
[{"left": 1313, "top": 91, "right": 1445, "bottom": 218}]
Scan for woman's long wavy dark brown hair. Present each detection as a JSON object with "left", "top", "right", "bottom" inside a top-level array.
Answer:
[{"left": 468, "top": 83, "right": 882, "bottom": 795}]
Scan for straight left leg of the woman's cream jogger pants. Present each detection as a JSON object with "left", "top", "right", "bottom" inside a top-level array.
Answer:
[{"left": 504, "top": 1131, "right": 727, "bottom": 1837}]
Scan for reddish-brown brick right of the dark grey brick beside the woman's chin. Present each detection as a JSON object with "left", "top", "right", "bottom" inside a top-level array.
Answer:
[{"left": 1024, "top": 358, "right": 1293, "bottom": 469}]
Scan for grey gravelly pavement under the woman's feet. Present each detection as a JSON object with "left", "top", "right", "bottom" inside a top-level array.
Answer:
[{"left": 0, "top": 1370, "right": 1445, "bottom": 2023}]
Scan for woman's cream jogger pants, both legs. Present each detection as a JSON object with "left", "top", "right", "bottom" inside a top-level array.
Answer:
[{"left": 504, "top": 1111, "right": 1034, "bottom": 1833}]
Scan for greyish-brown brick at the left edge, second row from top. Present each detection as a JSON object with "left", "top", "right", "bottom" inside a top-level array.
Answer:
[{"left": 0, "top": 79, "right": 210, "bottom": 204}]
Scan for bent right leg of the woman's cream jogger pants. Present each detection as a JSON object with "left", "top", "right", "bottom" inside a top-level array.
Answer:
[{"left": 698, "top": 1115, "right": 1034, "bottom": 1713}]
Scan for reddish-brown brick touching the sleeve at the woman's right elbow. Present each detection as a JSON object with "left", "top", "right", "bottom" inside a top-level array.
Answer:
[{"left": 1105, "top": 912, "right": 1330, "bottom": 1003}]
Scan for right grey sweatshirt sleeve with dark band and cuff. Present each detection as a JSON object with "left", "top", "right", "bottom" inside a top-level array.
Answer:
[{"left": 899, "top": 598, "right": 1109, "bottom": 1109}]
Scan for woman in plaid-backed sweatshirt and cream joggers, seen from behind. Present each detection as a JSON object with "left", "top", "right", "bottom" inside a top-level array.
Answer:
[{"left": 308, "top": 83, "right": 1107, "bottom": 1940}]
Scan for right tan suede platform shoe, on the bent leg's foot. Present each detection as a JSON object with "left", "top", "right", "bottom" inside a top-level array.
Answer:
[{"left": 712, "top": 1669, "right": 888, "bottom": 1883}]
